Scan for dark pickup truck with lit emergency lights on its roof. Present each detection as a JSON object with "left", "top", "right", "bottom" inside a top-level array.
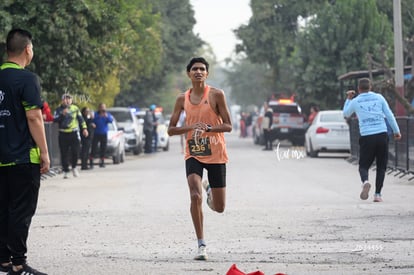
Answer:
[{"left": 253, "top": 98, "right": 306, "bottom": 146}]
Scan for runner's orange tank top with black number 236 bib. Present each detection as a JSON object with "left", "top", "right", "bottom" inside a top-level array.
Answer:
[{"left": 184, "top": 86, "right": 228, "bottom": 164}]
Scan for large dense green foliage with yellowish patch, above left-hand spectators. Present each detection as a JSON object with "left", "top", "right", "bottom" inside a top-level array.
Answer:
[{"left": 0, "top": 0, "right": 162, "bottom": 110}]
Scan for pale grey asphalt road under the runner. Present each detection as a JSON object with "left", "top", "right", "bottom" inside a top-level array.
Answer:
[{"left": 28, "top": 134, "right": 414, "bottom": 275}]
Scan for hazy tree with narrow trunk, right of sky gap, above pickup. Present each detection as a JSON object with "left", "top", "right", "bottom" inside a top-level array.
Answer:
[{"left": 235, "top": 0, "right": 323, "bottom": 91}]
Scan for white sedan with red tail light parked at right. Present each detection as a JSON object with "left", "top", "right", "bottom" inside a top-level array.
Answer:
[{"left": 305, "top": 110, "right": 351, "bottom": 157}]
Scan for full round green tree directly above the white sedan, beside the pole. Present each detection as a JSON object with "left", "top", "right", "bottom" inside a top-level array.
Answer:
[{"left": 296, "top": 0, "right": 392, "bottom": 108}]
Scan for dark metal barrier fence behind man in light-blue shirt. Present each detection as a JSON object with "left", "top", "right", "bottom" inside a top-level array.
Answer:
[{"left": 348, "top": 117, "right": 414, "bottom": 180}]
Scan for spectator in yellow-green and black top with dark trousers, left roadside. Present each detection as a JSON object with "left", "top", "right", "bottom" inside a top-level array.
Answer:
[{"left": 54, "top": 94, "right": 88, "bottom": 179}]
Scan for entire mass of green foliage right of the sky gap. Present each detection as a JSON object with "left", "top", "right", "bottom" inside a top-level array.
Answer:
[{"left": 231, "top": 0, "right": 402, "bottom": 108}]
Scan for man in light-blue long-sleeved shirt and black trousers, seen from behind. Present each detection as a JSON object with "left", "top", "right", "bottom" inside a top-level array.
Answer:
[{"left": 343, "top": 78, "right": 401, "bottom": 202}]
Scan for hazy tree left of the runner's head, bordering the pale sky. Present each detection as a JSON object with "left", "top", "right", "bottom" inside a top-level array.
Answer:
[{"left": 116, "top": 0, "right": 202, "bottom": 113}]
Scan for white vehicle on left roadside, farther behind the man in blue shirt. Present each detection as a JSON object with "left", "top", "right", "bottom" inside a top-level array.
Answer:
[{"left": 108, "top": 107, "right": 144, "bottom": 155}]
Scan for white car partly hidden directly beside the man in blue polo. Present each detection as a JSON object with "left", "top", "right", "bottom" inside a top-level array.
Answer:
[{"left": 106, "top": 119, "right": 125, "bottom": 164}]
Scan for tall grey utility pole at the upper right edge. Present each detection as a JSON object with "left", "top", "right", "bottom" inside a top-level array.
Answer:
[{"left": 393, "top": 0, "right": 405, "bottom": 116}]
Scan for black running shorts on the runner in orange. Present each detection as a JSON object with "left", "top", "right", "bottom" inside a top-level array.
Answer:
[{"left": 185, "top": 158, "right": 226, "bottom": 188}]
